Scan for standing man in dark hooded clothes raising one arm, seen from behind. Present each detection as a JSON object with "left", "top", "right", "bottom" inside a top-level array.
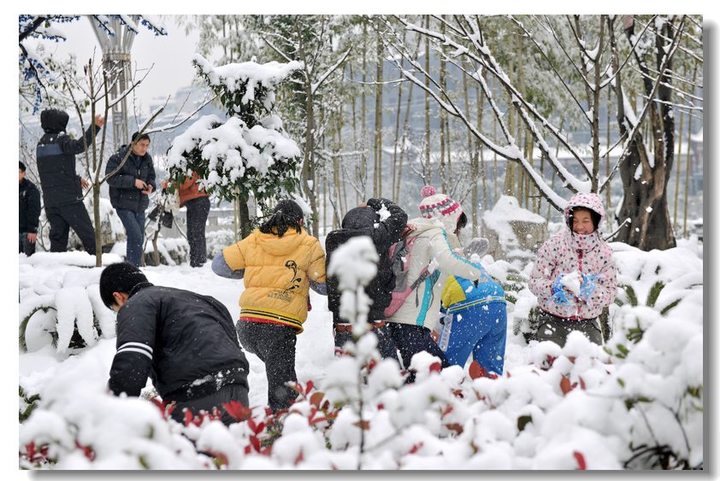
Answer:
[{"left": 37, "top": 109, "right": 105, "bottom": 255}]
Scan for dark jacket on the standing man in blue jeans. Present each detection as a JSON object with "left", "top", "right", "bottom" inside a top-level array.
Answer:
[{"left": 105, "top": 145, "right": 157, "bottom": 212}]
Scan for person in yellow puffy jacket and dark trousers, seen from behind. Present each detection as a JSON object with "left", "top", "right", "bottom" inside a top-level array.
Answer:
[{"left": 212, "top": 200, "right": 325, "bottom": 411}]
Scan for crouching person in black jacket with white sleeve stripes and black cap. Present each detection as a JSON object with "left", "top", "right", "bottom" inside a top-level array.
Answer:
[{"left": 100, "top": 262, "right": 248, "bottom": 424}]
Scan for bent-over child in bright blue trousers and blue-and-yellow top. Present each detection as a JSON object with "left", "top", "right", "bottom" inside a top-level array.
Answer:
[{"left": 438, "top": 276, "right": 507, "bottom": 376}]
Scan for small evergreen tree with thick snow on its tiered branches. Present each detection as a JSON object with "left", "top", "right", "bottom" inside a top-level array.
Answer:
[{"left": 168, "top": 55, "right": 302, "bottom": 236}]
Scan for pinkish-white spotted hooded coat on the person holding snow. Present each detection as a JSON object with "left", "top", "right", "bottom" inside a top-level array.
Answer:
[{"left": 529, "top": 194, "right": 617, "bottom": 319}]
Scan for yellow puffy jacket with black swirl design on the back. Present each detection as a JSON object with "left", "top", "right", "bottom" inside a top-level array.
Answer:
[{"left": 223, "top": 229, "right": 325, "bottom": 334}]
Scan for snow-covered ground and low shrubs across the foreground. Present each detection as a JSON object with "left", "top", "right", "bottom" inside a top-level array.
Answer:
[{"left": 11, "top": 236, "right": 703, "bottom": 470}]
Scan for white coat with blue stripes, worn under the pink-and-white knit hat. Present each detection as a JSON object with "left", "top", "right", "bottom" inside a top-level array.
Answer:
[{"left": 388, "top": 218, "right": 487, "bottom": 330}]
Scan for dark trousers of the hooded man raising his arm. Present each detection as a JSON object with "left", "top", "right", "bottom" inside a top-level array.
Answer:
[{"left": 45, "top": 202, "right": 95, "bottom": 255}]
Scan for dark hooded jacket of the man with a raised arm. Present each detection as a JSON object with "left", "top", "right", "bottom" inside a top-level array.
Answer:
[{"left": 36, "top": 109, "right": 100, "bottom": 207}]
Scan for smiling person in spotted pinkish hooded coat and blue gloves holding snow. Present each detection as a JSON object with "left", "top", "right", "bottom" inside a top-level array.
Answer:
[{"left": 530, "top": 194, "right": 617, "bottom": 346}]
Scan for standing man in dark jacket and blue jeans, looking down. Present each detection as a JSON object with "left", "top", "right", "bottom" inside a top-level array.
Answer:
[{"left": 105, "top": 132, "right": 156, "bottom": 266}]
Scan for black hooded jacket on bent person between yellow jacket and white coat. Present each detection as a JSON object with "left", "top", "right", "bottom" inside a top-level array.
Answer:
[{"left": 325, "top": 199, "right": 407, "bottom": 324}]
